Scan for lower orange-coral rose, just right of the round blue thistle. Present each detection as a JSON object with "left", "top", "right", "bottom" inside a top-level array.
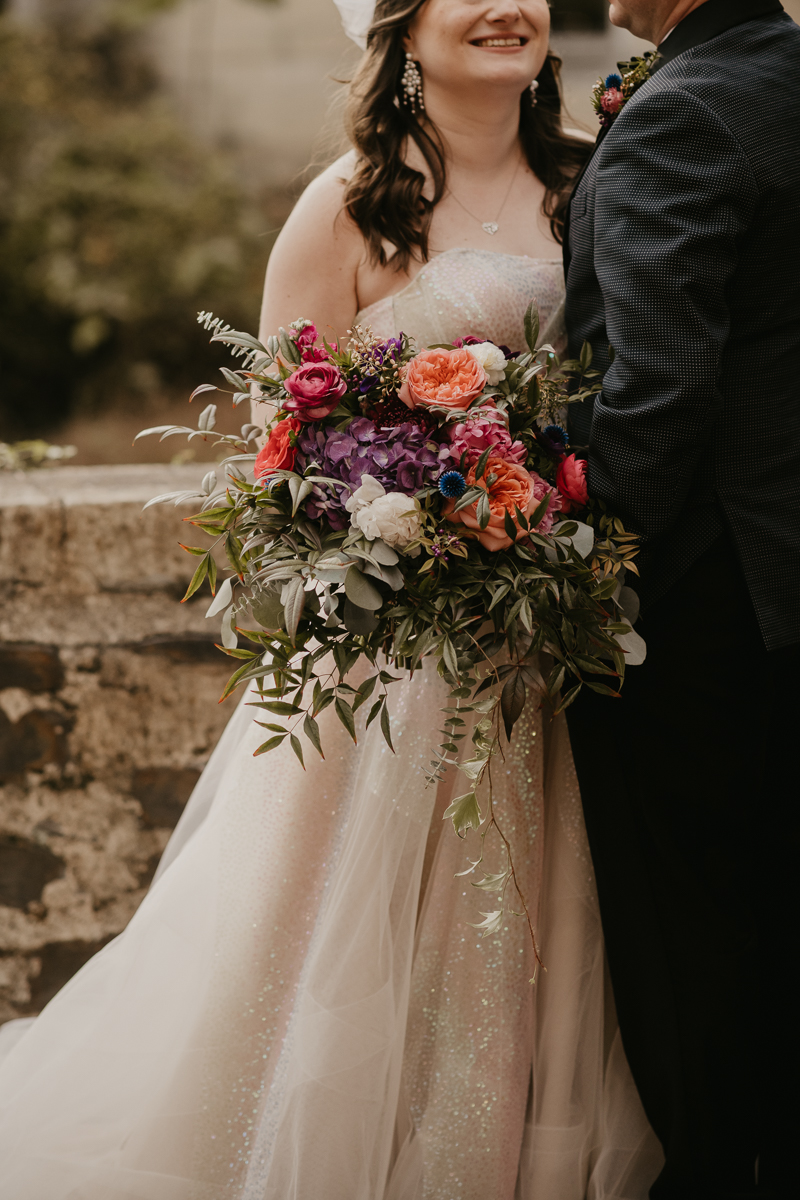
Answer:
[{"left": 445, "top": 456, "right": 561, "bottom": 550}]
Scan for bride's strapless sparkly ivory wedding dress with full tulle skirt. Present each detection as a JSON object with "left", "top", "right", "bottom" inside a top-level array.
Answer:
[{"left": 0, "top": 250, "right": 661, "bottom": 1200}]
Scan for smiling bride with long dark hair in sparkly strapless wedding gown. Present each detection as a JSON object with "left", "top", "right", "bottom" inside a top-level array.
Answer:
[{"left": 0, "top": 0, "right": 660, "bottom": 1200}]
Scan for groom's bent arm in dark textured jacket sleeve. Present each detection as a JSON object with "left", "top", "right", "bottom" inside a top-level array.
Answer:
[{"left": 589, "top": 90, "right": 758, "bottom": 540}]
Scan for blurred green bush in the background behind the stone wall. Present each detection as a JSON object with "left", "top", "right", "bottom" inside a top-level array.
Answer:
[{"left": 0, "top": 10, "right": 270, "bottom": 440}]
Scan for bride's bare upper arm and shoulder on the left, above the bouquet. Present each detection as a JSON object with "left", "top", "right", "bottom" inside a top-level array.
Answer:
[{"left": 252, "top": 154, "right": 365, "bottom": 425}]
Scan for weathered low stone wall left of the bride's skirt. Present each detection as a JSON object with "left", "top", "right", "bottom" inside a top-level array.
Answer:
[{"left": 0, "top": 466, "right": 236, "bottom": 1021}]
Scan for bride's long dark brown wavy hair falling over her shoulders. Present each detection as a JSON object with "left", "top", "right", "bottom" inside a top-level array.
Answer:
[{"left": 344, "top": 0, "right": 591, "bottom": 270}]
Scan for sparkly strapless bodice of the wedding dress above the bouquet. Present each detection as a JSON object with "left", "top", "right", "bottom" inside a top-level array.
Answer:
[{"left": 356, "top": 248, "right": 564, "bottom": 350}]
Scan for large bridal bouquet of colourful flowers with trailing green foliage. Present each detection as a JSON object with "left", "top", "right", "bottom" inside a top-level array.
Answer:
[{"left": 139, "top": 305, "right": 642, "bottom": 955}]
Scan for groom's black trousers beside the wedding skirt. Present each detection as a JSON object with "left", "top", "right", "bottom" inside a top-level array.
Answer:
[{"left": 567, "top": 538, "right": 800, "bottom": 1200}]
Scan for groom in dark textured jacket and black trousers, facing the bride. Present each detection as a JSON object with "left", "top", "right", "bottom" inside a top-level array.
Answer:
[{"left": 565, "top": 0, "right": 800, "bottom": 1200}]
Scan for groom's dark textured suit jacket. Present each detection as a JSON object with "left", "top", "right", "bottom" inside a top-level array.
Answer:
[{"left": 565, "top": 0, "right": 800, "bottom": 648}]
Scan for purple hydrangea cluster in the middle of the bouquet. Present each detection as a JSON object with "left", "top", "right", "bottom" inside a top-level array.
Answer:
[{"left": 296, "top": 416, "right": 449, "bottom": 529}]
